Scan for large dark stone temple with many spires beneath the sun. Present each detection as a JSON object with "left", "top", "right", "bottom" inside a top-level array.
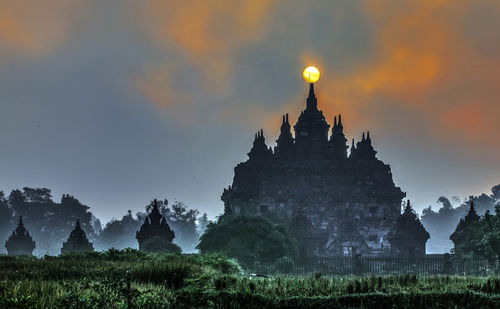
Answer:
[{"left": 221, "top": 84, "right": 418, "bottom": 256}]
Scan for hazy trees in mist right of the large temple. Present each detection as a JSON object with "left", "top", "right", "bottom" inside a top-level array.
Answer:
[{"left": 420, "top": 184, "right": 500, "bottom": 253}]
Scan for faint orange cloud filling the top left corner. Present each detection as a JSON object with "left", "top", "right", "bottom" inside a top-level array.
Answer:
[{"left": 0, "top": 0, "right": 86, "bottom": 54}]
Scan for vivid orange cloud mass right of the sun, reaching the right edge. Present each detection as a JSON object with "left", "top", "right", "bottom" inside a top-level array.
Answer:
[{"left": 308, "top": 0, "right": 500, "bottom": 154}]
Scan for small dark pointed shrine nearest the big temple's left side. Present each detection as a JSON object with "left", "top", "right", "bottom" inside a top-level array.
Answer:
[{"left": 136, "top": 200, "right": 180, "bottom": 252}]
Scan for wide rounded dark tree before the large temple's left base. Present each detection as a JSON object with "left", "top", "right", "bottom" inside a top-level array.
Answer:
[{"left": 196, "top": 215, "right": 297, "bottom": 267}]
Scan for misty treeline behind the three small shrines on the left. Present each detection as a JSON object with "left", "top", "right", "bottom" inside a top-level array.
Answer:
[{"left": 0, "top": 187, "right": 209, "bottom": 255}]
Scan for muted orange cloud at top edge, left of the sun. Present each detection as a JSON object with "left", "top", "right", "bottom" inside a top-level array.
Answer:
[{"left": 139, "top": 0, "right": 272, "bottom": 92}]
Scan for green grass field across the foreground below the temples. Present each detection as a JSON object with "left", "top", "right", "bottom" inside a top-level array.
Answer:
[{"left": 0, "top": 250, "right": 500, "bottom": 308}]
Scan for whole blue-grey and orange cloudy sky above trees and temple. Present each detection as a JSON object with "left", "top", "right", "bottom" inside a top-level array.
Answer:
[{"left": 0, "top": 0, "right": 500, "bottom": 221}]
